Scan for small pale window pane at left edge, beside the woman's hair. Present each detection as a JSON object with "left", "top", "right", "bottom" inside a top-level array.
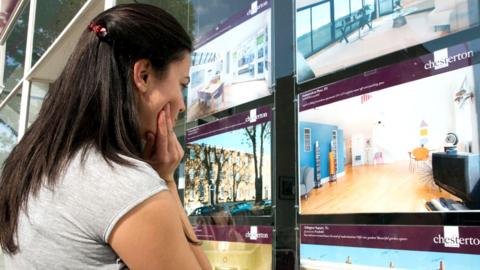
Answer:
[{"left": 0, "top": 91, "right": 21, "bottom": 167}]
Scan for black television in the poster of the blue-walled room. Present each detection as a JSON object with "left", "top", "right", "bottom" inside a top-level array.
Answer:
[{"left": 432, "top": 152, "right": 480, "bottom": 209}]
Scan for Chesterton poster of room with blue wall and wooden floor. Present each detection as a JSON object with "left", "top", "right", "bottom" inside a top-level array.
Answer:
[{"left": 298, "top": 39, "right": 480, "bottom": 214}]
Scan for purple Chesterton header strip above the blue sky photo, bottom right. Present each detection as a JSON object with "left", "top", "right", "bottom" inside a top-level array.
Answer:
[{"left": 301, "top": 224, "right": 480, "bottom": 255}]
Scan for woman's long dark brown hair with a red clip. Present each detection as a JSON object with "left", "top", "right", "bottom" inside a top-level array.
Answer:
[{"left": 0, "top": 4, "right": 192, "bottom": 254}]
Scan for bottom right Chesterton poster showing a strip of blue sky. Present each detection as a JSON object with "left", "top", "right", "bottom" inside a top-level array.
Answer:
[{"left": 300, "top": 224, "right": 480, "bottom": 270}]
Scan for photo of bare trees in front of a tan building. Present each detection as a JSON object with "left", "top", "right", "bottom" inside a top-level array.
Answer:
[{"left": 185, "top": 123, "right": 271, "bottom": 214}]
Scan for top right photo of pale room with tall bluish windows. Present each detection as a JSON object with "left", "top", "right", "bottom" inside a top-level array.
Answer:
[{"left": 296, "top": 0, "right": 479, "bottom": 82}]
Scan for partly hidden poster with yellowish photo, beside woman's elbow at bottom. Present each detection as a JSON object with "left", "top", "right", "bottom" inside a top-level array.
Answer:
[{"left": 194, "top": 226, "right": 272, "bottom": 270}]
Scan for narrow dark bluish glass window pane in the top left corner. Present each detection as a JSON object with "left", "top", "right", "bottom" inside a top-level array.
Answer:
[{"left": 2, "top": 2, "right": 29, "bottom": 94}]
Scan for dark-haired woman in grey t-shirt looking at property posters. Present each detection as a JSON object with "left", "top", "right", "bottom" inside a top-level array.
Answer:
[{"left": 0, "top": 4, "right": 211, "bottom": 269}]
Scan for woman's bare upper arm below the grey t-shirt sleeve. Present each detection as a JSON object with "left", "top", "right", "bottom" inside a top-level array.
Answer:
[{"left": 108, "top": 192, "right": 202, "bottom": 270}]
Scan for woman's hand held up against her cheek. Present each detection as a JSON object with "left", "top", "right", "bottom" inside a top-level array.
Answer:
[{"left": 143, "top": 103, "right": 184, "bottom": 182}]
